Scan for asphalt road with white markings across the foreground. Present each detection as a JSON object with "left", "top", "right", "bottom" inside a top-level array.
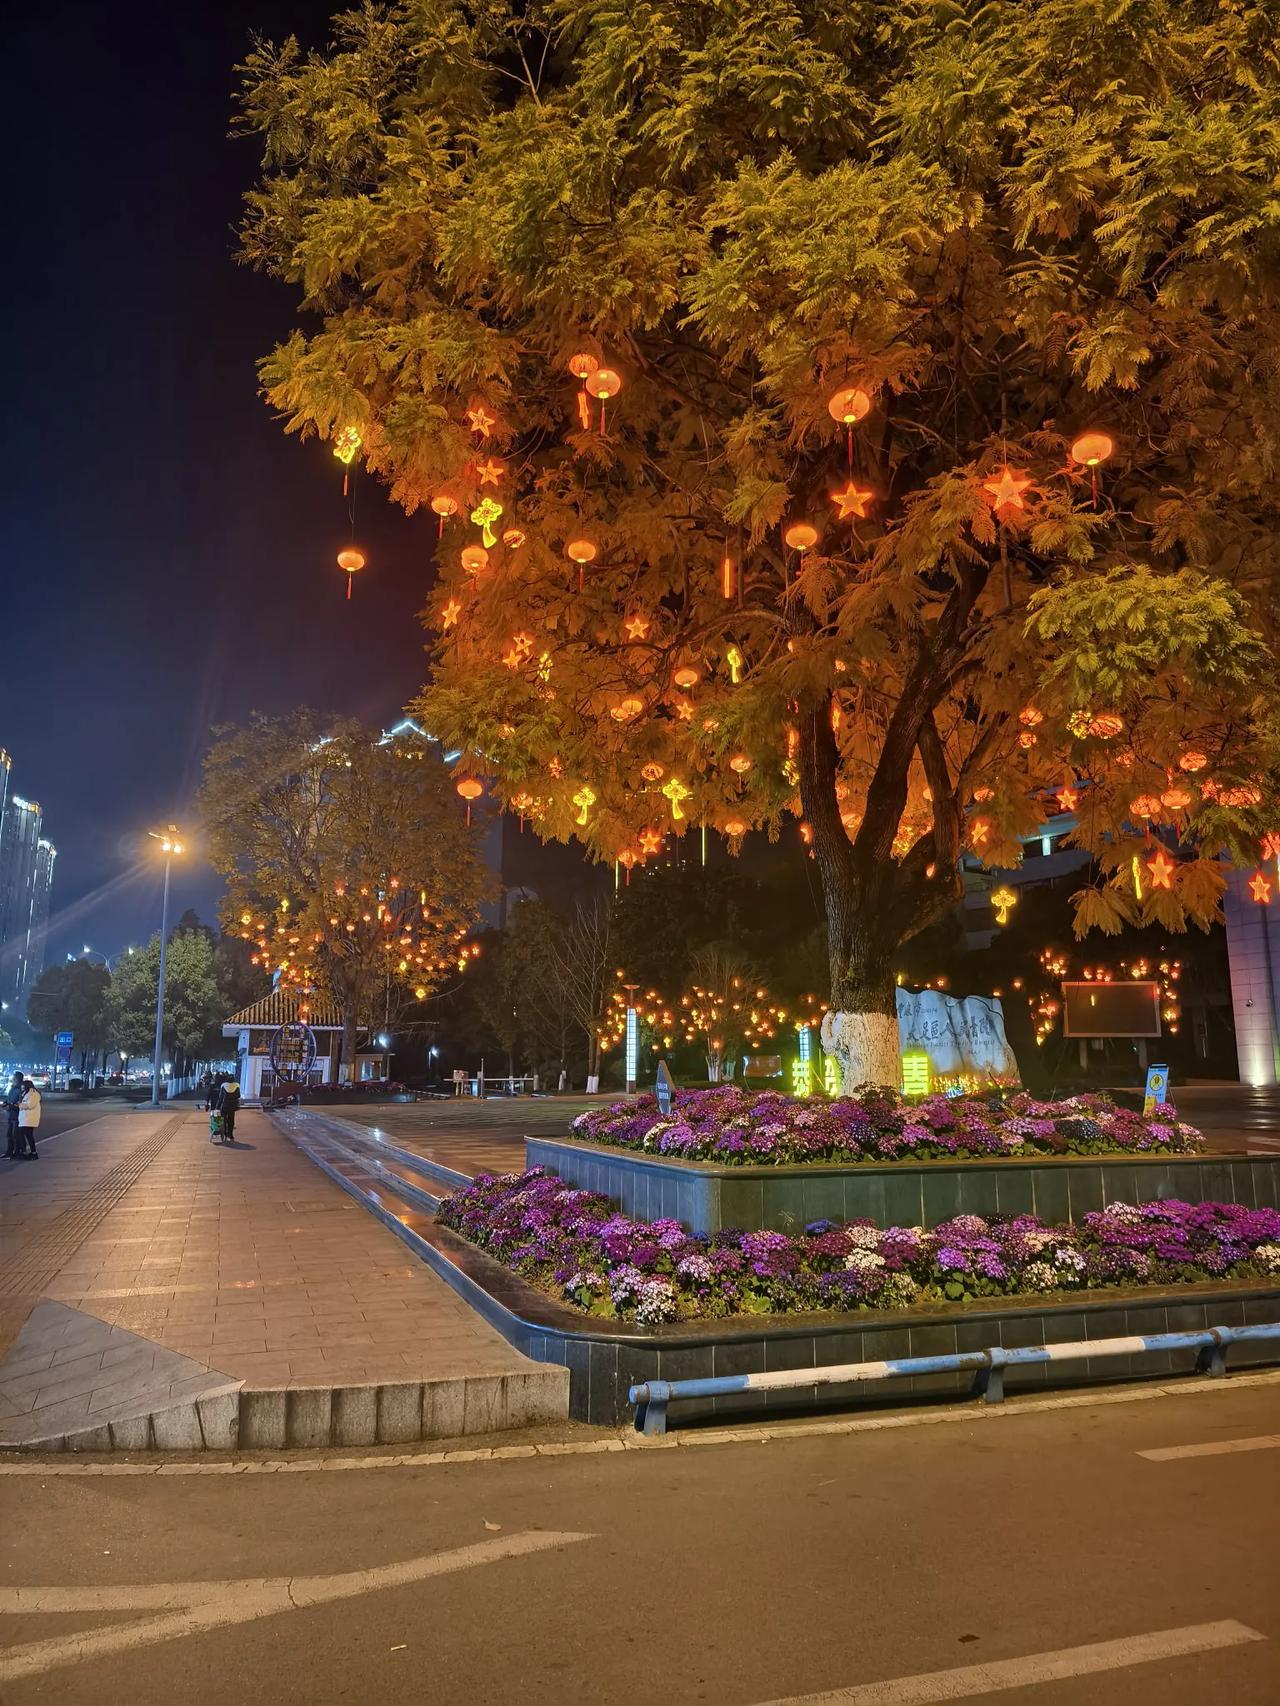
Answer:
[{"left": 0, "top": 1382, "right": 1280, "bottom": 1706}]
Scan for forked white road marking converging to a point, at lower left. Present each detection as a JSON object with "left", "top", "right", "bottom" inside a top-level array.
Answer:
[{"left": 0, "top": 1530, "right": 592, "bottom": 1682}]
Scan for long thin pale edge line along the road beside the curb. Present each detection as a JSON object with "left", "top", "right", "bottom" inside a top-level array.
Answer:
[{"left": 0, "top": 1370, "right": 1280, "bottom": 1481}]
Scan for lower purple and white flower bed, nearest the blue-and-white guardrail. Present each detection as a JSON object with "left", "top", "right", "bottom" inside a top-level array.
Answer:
[{"left": 439, "top": 1169, "right": 1280, "bottom": 1326}]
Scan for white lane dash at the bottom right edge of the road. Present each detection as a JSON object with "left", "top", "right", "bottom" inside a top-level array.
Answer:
[{"left": 757, "top": 1619, "right": 1266, "bottom": 1706}]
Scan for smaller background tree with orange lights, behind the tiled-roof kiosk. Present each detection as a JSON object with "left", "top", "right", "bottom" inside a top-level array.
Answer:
[{"left": 200, "top": 711, "right": 488, "bottom": 1075}]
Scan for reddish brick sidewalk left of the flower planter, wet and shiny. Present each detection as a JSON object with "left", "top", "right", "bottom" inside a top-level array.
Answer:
[{"left": 0, "top": 1109, "right": 531, "bottom": 1387}]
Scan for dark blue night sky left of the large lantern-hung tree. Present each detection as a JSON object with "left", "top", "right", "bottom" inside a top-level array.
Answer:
[{"left": 0, "top": 0, "right": 433, "bottom": 959}]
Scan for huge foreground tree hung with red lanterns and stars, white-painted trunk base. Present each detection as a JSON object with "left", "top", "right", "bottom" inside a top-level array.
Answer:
[{"left": 242, "top": 0, "right": 1280, "bottom": 1085}]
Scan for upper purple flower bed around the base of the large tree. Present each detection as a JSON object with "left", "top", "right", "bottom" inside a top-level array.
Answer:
[{"left": 572, "top": 1085, "right": 1203, "bottom": 1167}]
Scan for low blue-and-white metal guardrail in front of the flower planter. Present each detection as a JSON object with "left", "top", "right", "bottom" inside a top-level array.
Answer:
[{"left": 628, "top": 1320, "right": 1280, "bottom": 1435}]
